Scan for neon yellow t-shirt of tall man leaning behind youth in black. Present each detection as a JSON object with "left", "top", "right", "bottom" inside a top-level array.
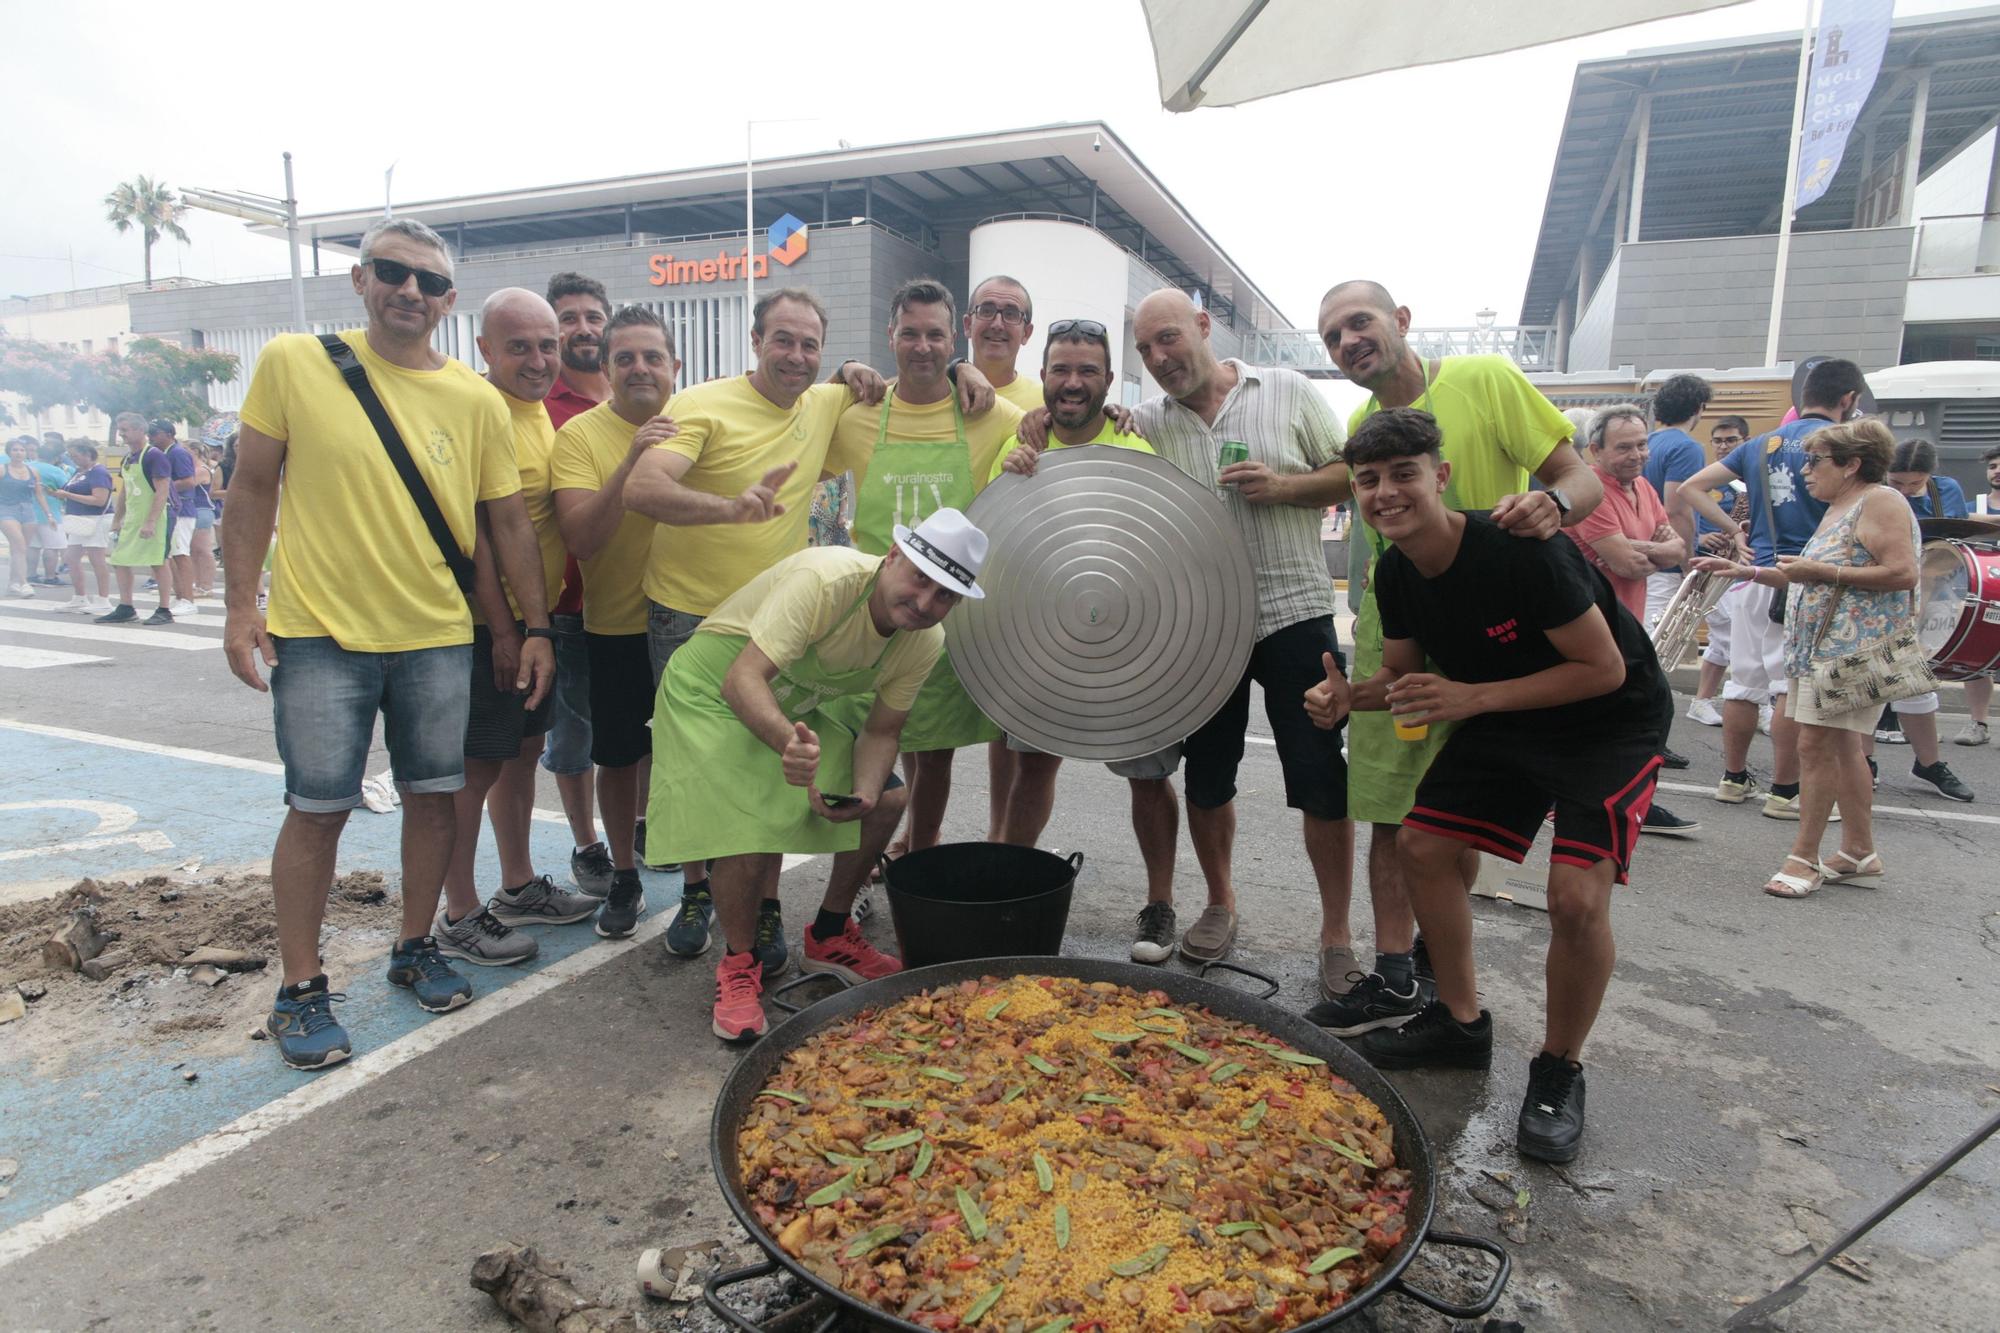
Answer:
[{"left": 1348, "top": 356, "right": 1572, "bottom": 560}]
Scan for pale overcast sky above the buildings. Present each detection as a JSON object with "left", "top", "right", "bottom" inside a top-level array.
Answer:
[{"left": 0, "top": 0, "right": 1966, "bottom": 324}]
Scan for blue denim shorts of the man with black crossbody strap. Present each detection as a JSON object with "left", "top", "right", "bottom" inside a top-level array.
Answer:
[{"left": 270, "top": 636, "right": 472, "bottom": 815}]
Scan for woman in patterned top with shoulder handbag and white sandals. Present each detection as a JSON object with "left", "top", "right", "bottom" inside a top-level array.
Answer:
[{"left": 1694, "top": 420, "right": 1936, "bottom": 899}]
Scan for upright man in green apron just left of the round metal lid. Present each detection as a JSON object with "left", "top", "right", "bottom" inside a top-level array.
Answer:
[{"left": 826, "top": 278, "right": 1022, "bottom": 849}]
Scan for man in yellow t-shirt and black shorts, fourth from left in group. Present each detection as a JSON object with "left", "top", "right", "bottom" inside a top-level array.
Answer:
[{"left": 550, "top": 306, "right": 680, "bottom": 939}]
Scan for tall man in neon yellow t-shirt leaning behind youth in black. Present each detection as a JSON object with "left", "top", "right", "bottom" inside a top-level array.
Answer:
[{"left": 1308, "top": 280, "right": 1604, "bottom": 1037}]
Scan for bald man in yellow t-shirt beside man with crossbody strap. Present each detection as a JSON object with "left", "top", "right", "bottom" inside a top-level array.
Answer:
[{"left": 436, "top": 286, "right": 598, "bottom": 967}]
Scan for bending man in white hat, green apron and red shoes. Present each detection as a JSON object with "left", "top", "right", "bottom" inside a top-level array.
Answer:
[{"left": 646, "top": 508, "right": 986, "bottom": 1041}]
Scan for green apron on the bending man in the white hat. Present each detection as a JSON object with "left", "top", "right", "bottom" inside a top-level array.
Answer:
[{"left": 646, "top": 578, "right": 894, "bottom": 863}]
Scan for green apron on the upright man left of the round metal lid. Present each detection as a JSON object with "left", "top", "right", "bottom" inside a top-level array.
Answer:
[{"left": 852, "top": 394, "right": 1002, "bottom": 748}]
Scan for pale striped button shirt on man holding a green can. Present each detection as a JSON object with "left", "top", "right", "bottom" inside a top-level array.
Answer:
[{"left": 1134, "top": 358, "right": 1346, "bottom": 638}]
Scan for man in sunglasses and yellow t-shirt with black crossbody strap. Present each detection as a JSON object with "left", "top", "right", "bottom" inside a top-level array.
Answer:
[{"left": 222, "top": 218, "right": 554, "bottom": 1069}]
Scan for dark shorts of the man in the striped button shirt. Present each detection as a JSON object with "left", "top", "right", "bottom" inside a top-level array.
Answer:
[{"left": 1182, "top": 616, "right": 1348, "bottom": 819}]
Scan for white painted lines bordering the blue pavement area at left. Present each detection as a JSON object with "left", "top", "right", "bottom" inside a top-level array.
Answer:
[{"left": 0, "top": 719, "right": 818, "bottom": 1267}]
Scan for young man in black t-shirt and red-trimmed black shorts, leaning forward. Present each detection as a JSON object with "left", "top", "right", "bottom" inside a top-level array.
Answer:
[{"left": 1306, "top": 408, "right": 1672, "bottom": 1161}]
